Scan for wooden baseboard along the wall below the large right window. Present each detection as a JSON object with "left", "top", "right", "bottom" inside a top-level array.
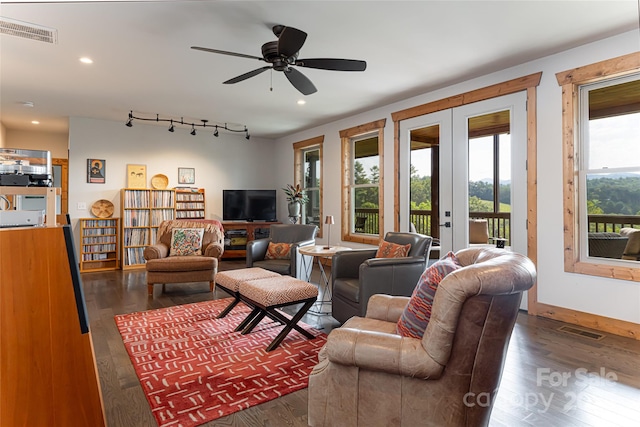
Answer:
[{"left": 536, "top": 303, "right": 640, "bottom": 341}]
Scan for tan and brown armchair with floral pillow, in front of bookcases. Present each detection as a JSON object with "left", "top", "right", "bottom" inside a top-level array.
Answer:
[{"left": 143, "top": 220, "right": 224, "bottom": 296}]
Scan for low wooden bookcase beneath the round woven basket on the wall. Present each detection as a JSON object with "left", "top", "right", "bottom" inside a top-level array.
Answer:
[{"left": 80, "top": 218, "right": 120, "bottom": 272}]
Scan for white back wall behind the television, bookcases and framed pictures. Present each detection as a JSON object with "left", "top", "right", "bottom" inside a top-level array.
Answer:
[{"left": 69, "top": 117, "right": 278, "bottom": 224}]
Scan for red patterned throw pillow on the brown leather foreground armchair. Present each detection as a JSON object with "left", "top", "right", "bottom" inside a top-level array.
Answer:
[{"left": 396, "top": 252, "right": 461, "bottom": 339}]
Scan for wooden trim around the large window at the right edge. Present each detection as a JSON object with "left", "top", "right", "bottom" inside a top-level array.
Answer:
[{"left": 556, "top": 52, "right": 640, "bottom": 282}]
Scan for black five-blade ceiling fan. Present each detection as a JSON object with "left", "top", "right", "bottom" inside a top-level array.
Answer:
[{"left": 191, "top": 25, "right": 367, "bottom": 95}]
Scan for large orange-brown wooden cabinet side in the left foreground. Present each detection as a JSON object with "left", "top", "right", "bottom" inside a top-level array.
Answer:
[{"left": 0, "top": 227, "right": 105, "bottom": 427}]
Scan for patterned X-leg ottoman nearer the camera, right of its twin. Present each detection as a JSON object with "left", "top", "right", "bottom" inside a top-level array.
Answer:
[{"left": 236, "top": 276, "right": 318, "bottom": 351}]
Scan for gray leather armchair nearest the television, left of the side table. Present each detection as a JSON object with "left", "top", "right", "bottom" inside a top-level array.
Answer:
[{"left": 247, "top": 224, "right": 318, "bottom": 280}]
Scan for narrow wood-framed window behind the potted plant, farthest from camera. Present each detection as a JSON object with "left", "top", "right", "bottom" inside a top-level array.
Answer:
[{"left": 293, "top": 136, "right": 324, "bottom": 237}]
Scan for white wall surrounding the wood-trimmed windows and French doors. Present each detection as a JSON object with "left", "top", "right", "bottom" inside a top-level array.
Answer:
[{"left": 275, "top": 31, "right": 640, "bottom": 323}]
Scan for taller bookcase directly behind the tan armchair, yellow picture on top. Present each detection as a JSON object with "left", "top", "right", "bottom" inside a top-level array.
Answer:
[{"left": 120, "top": 188, "right": 175, "bottom": 270}]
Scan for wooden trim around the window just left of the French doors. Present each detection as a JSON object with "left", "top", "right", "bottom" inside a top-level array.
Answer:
[{"left": 339, "top": 119, "right": 387, "bottom": 245}]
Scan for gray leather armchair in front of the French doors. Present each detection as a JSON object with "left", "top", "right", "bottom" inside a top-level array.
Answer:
[{"left": 331, "top": 232, "right": 432, "bottom": 323}]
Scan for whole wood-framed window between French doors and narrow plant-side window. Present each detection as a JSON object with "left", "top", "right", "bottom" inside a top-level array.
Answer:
[{"left": 340, "top": 119, "right": 386, "bottom": 245}]
